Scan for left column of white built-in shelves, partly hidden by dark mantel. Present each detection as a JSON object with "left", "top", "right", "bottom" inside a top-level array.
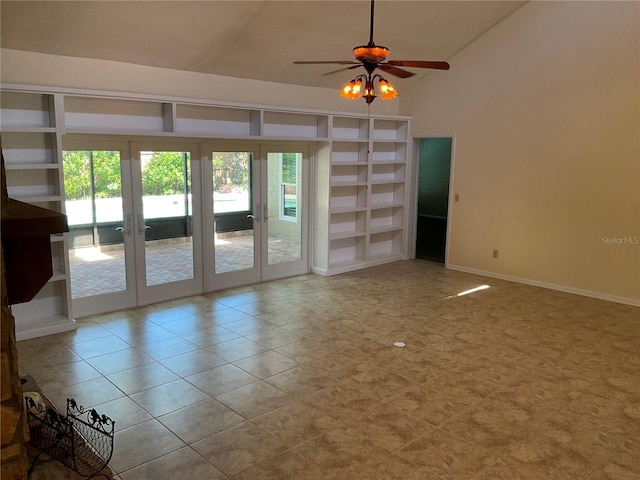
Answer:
[{"left": 0, "top": 91, "right": 75, "bottom": 340}]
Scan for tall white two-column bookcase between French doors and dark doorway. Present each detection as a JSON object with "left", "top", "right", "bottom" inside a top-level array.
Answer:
[{"left": 314, "top": 115, "right": 409, "bottom": 275}]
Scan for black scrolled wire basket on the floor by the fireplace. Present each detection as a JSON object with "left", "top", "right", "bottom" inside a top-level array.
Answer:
[{"left": 25, "top": 397, "right": 115, "bottom": 479}]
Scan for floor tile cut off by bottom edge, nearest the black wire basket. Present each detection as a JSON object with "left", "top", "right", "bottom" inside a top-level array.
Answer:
[{"left": 122, "top": 447, "right": 227, "bottom": 480}]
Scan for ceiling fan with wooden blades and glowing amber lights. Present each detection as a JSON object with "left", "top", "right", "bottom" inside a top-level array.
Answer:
[{"left": 293, "top": 0, "right": 449, "bottom": 103}]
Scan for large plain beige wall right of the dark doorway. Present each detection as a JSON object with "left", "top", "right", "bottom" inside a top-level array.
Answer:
[{"left": 400, "top": 2, "right": 640, "bottom": 304}]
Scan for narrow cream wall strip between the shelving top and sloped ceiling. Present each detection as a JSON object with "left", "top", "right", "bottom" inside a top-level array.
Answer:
[{"left": 0, "top": 49, "right": 399, "bottom": 115}]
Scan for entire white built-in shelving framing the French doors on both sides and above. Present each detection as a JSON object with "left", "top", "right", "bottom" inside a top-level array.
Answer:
[{"left": 0, "top": 85, "right": 410, "bottom": 338}]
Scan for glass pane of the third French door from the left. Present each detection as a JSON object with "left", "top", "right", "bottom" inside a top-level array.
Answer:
[{"left": 211, "top": 151, "right": 255, "bottom": 275}]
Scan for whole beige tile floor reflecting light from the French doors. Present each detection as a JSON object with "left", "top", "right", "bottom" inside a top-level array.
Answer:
[{"left": 18, "top": 260, "right": 640, "bottom": 480}]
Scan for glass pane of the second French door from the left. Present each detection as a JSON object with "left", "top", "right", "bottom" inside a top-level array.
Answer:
[{"left": 142, "top": 151, "right": 194, "bottom": 286}]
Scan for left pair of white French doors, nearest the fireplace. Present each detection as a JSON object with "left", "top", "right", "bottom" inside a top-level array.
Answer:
[{"left": 63, "top": 137, "right": 204, "bottom": 317}]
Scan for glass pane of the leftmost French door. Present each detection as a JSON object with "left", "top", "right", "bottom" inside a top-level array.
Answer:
[{"left": 62, "top": 150, "right": 131, "bottom": 300}]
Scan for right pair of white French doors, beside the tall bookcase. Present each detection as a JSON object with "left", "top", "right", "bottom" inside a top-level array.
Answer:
[{"left": 204, "top": 143, "right": 309, "bottom": 290}]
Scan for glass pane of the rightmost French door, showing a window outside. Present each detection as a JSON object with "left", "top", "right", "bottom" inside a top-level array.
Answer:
[{"left": 265, "top": 152, "right": 302, "bottom": 265}]
